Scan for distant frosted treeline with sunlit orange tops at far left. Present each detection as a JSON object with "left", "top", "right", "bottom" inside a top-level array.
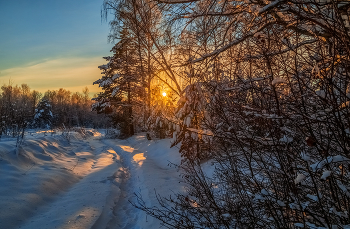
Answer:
[{"left": 0, "top": 83, "right": 108, "bottom": 137}]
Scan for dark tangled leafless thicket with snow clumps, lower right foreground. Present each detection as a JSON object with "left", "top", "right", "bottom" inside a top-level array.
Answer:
[{"left": 139, "top": 69, "right": 350, "bottom": 228}]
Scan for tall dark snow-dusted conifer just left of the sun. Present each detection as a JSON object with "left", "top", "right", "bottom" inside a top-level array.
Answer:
[{"left": 93, "top": 28, "right": 142, "bottom": 136}]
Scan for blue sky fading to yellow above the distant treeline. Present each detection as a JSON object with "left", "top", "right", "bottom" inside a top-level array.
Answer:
[{"left": 0, "top": 0, "right": 113, "bottom": 94}]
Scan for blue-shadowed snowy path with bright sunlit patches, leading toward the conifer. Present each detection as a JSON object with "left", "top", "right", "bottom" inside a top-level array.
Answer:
[{"left": 96, "top": 136, "right": 180, "bottom": 229}]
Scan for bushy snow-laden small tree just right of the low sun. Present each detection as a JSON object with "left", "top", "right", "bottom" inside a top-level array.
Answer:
[{"left": 172, "top": 83, "right": 215, "bottom": 161}]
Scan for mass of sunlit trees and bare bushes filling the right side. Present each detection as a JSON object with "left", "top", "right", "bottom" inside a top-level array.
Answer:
[{"left": 94, "top": 0, "right": 350, "bottom": 228}]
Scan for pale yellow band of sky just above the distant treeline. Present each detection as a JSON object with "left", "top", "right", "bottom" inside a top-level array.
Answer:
[{"left": 0, "top": 56, "right": 103, "bottom": 96}]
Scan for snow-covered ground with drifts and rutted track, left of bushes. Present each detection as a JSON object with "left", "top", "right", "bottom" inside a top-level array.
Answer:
[{"left": 0, "top": 130, "right": 183, "bottom": 229}]
